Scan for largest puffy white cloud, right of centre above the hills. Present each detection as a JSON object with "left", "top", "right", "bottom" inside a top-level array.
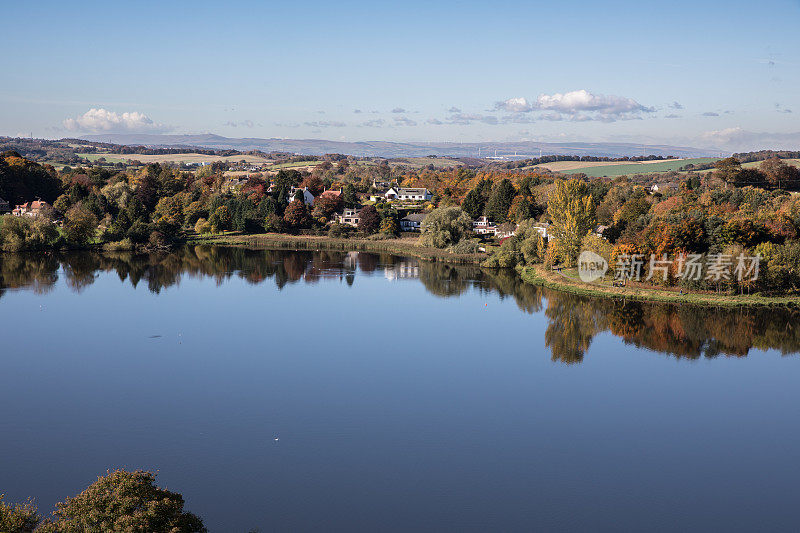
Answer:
[{"left": 494, "top": 89, "right": 656, "bottom": 122}]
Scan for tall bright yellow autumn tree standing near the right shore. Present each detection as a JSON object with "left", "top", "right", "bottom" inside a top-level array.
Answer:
[{"left": 547, "top": 179, "right": 595, "bottom": 266}]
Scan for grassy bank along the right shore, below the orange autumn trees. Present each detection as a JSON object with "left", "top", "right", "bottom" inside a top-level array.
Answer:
[{"left": 517, "top": 265, "right": 800, "bottom": 307}]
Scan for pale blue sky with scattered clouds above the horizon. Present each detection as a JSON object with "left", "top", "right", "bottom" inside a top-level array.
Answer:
[{"left": 0, "top": 0, "right": 800, "bottom": 151}]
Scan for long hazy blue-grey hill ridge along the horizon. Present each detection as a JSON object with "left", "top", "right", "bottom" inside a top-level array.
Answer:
[{"left": 80, "top": 134, "right": 719, "bottom": 159}]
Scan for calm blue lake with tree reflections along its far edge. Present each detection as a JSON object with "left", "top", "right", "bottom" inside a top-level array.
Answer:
[{"left": 0, "top": 247, "right": 800, "bottom": 532}]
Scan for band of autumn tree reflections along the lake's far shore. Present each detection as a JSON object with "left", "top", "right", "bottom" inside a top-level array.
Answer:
[{"left": 0, "top": 246, "right": 800, "bottom": 363}]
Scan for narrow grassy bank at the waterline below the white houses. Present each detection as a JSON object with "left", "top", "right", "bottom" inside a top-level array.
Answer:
[{"left": 189, "top": 233, "right": 487, "bottom": 265}]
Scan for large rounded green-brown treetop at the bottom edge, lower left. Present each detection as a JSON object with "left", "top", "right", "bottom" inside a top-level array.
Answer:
[{"left": 36, "top": 470, "right": 206, "bottom": 533}]
